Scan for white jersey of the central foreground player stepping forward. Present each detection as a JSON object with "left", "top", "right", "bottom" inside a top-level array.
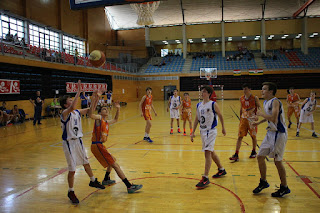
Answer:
[{"left": 197, "top": 101, "right": 218, "bottom": 131}]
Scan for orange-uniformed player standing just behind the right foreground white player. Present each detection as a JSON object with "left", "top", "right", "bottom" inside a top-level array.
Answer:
[{"left": 229, "top": 84, "right": 260, "bottom": 161}]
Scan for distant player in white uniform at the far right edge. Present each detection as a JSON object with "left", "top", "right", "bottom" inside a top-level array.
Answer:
[{"left": 296, "top": 91, "right": 318, "bottom": 138}]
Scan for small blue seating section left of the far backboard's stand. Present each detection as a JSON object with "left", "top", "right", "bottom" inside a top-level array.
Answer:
[{"left": 145, "top": 56, "right": 185, "bottom": 73}]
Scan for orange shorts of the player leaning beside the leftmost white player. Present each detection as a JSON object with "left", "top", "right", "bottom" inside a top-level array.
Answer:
[{"left": 91, "top": 142, "right": 116, "bottom": 168}]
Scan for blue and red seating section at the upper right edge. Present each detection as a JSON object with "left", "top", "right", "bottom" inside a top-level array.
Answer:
[{"left": 263, "top": 47, "right": 320, "bottom": 69}]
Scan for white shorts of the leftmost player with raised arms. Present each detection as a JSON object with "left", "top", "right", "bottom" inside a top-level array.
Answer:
[{"left": 62, "top": 138, "right": 89, "bottom": 171}]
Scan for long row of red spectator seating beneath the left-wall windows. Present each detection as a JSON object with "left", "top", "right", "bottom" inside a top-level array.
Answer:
[{"left": 0, "top": 37, "right": 138, "bottom": 73}]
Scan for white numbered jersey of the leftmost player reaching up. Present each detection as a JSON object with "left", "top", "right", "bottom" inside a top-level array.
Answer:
[{"left": 61, "top": 110, "right": 83, "bottom": 141}]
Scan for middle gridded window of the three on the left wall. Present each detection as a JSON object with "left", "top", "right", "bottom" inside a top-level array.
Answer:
[{"left": 29, "top": 24, "right": 60, "bottom": 51}]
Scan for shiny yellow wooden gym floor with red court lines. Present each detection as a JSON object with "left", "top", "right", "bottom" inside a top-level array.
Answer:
[{"left": 0, "top": 100, "right": 320, "bottom": 212}]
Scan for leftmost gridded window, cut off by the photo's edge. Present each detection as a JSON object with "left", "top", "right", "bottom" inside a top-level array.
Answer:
[{"left": 0, "top": 15, "right": 24, "bottom": 40}]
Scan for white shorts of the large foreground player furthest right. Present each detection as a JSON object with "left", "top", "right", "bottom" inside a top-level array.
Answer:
[{"left": 258, "top": 131, "right": 288, "bottom": 161}]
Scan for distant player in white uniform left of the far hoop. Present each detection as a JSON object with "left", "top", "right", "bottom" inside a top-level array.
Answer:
[{"left": 167, "top": 89, "right": 181, "bottom": 134}]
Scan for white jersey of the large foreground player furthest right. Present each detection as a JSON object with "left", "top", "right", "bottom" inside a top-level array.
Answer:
[{"left": 263, "top": 97, "right": 287, "bottom": 132}]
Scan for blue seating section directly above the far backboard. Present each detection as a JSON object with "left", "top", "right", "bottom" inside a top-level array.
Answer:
[{"left": 190, "top": 51, "right": 257, "bottom": 71}]
